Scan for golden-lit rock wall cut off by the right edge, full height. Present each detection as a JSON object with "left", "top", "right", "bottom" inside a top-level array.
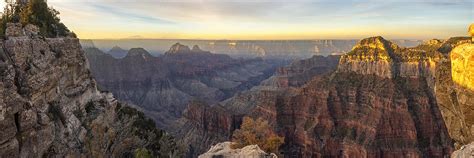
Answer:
[{"left": 435, "top": 44, "right": 474, "bottom": 148}]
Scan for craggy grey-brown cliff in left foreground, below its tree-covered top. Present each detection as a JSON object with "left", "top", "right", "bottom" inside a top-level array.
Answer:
[{"left": 0, "top": 24, "right": 180, "bottom": 157}]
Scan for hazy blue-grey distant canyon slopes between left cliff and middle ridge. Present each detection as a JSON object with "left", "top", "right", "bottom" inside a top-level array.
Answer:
[{"left": 86, "top": 43, "right": 282, "bottom": 130}]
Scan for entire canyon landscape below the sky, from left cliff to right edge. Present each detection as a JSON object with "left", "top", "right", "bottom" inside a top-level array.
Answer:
[{"left": 0, "top": 0, "right": 474, "bottom": 158}]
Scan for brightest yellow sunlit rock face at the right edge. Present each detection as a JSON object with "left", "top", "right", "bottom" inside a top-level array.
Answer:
[{"left": 451, "top": 44, "right": 474, "bottom": 91}]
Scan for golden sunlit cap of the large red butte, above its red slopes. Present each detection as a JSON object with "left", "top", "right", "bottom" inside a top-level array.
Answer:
[{"left": 338, "top": 36, "right": 443, "bottom": 82}]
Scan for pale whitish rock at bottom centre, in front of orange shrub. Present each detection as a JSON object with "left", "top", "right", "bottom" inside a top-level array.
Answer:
[{"left": 199, "top": 142, "right": 277, "bottom": 158}]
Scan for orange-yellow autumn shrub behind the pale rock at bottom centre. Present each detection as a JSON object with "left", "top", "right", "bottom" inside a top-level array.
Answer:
[{"left": 232, "top": 117, "right": 285, "bottom": 153}]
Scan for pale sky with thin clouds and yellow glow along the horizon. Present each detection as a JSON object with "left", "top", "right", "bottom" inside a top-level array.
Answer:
[{"left": 0, "top": 0, "right": 474, "bottom": 40}]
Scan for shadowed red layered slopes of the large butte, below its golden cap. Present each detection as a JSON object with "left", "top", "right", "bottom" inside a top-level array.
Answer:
[{"left": 246, "top": 73, "right": 453, "bottom": 157}]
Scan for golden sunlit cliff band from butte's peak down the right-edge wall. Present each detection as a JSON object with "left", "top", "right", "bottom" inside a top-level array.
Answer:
[{"left": 338, "top": 37, "right": 474, "bottom": 148}]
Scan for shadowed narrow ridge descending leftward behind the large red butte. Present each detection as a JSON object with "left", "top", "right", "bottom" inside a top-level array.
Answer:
[{"left": 173, "top": 56, "right": 339, "bottom": 157}]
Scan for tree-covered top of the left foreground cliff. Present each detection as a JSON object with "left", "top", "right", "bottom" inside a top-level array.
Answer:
[{"left": 0, "top": 0, "right": 76, "bottom": 38}]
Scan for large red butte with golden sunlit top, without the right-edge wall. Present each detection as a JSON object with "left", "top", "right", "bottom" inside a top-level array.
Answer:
[{"left": 248, "top": 37, "right": 453, "bottom": 157}]
